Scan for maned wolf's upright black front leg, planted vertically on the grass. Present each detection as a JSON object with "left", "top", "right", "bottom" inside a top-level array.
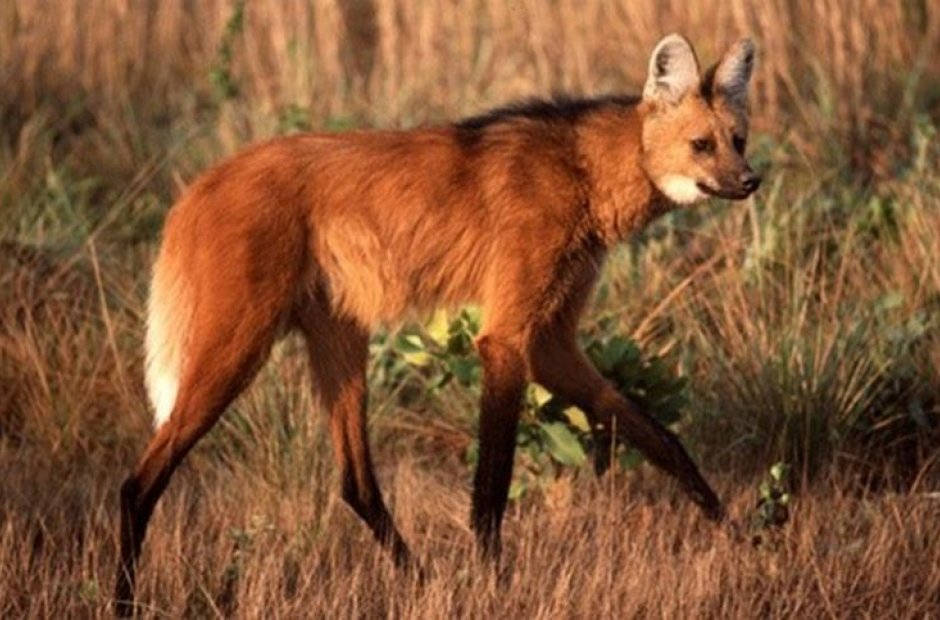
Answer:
[{"left": 471, "top": 336, "right": 526, "bottom": 559}]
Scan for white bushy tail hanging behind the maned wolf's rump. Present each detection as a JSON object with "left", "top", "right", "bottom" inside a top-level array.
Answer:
[{"left": 145, "top": 248, "right": 192, "bottom": 428}]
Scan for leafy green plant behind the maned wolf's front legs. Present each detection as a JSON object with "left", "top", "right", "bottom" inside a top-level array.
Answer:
[{"left": 381, "top": 308, "right": 688, "bottom": 498}]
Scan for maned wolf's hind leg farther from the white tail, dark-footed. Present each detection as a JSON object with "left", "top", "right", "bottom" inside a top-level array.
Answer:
[{"left": 301, "top": 302, "right": 414, "bottom": 568}]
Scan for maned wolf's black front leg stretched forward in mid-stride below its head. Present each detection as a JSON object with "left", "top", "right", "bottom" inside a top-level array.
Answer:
[{"left": 529, "top": 333, "right": 724, "bottom": 521}]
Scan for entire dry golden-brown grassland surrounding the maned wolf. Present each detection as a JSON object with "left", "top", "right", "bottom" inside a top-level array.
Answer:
[{"left": 0, "top": 0, "right": 940, "bottom": 618}]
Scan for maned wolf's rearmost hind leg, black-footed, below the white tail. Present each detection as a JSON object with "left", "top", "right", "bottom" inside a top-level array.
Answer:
[{"left": 115, "top": 306, "right": 276, "bottom": 616}]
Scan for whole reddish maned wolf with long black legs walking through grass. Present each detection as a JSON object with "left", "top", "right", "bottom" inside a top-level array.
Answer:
[{"left": 116, "top": 35, "right": 760, "bottom": 613}]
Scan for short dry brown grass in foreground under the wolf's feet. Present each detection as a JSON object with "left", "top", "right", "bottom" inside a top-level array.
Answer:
[{"left": 0, "top": 449, "right": 940, "bottom": 618}]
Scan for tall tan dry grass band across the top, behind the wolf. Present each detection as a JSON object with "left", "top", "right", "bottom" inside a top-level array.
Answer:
[{"left": 0, "top": 0, "right": 940, "bottom": 173}]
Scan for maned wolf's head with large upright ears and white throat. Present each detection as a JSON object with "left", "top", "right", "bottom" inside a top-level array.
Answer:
[{"left": 643, "top": 34, "right": 761, "bottom": 204}]
